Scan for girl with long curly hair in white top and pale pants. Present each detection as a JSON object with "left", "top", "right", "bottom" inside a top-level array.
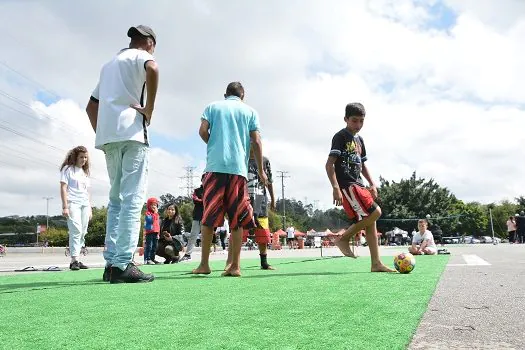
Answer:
[{"left": 60, "top": 146, "right": 92, "bottom": 270}]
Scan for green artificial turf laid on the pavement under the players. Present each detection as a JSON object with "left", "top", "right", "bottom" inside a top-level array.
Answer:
[{"left": 0, "top": 256, "right": 448, "bottom": 350}]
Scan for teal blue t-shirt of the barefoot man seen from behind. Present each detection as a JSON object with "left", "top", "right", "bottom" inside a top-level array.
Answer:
[{"left": 201, "top": 96, "right": 259, "bottom": 178}]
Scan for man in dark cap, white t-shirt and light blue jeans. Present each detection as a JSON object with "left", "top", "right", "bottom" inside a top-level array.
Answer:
[{"left": 86, "top": 25, "right": 159, "bottom": 283}]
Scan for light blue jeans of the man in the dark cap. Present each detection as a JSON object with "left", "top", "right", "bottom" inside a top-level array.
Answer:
[{"left": 103, "top": 141, "right": 149, "bottom": 270}]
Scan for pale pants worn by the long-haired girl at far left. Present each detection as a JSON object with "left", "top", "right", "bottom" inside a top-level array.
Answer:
[{"left": 67, "top": 202, "right": 91, "bottom": 257}]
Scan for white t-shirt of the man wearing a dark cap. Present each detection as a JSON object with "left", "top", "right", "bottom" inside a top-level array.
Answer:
[{"left": 91, "top": 49, "right": 155, "bottom": 149}]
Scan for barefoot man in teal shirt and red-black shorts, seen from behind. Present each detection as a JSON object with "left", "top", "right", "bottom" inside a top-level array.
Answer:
[{"left": 193, "top": 82, "right": 268, "bottom": 276}]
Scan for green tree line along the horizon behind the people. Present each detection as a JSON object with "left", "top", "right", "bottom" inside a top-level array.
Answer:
[{"left": 0, "top": 172, "right": 525, "bottom": 246}]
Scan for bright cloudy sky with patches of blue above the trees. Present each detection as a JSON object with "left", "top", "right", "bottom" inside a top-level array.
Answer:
[{"left": 0, "top": 0, "right": 525, "bottom": 216}]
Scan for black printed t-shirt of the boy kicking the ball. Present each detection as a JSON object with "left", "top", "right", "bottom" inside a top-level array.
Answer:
[{"left": 330, "top": 129, "right": 366, "bottom": 188}]
